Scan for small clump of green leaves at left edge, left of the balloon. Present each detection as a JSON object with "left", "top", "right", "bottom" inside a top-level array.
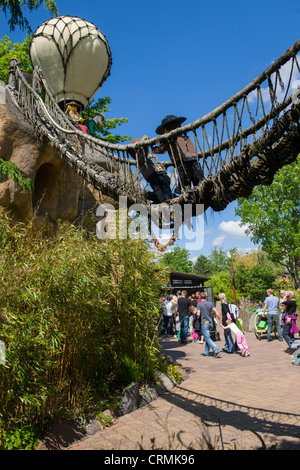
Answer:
[{"left": 0, "top": 35, "right": 32, "bottom": 84}]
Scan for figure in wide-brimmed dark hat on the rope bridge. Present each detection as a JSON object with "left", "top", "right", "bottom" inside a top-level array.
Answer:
[{"left": 152, "top": 115, "right": 204, "bottom": 194}]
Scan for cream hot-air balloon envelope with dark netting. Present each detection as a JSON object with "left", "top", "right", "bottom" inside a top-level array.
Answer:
[{"left": 30, "top": 16, "right": 112, "bottom": 107}]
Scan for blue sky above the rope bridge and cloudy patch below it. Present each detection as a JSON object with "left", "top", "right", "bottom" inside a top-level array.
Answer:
[{"left": 0, "top": 0, "right": 300, "bottom": 258}]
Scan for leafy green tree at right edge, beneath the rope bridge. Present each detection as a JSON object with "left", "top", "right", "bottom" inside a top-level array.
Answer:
[{"left": 236, "top": 156, "right": 300, "bottom": 289}]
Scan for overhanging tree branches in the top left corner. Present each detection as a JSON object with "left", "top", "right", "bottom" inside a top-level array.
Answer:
[{"left": 0, "top": 0, "right": 58, "bottom": 32}]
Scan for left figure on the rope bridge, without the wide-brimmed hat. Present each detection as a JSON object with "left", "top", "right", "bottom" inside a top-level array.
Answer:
[{"left": 128, "top": 136, "right": 173, "bottom": 204}]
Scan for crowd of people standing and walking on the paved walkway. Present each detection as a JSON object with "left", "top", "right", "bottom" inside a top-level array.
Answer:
[{"left": 160, "top": 289, "right": 299, "bottom": 358}]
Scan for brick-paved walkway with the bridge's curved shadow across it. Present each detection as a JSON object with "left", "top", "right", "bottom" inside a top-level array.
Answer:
[{"left": 69, "top": 333, "right": 300, "bottom": 450}]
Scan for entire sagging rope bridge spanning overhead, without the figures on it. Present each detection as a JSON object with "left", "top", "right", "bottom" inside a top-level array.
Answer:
[{"left": 8, "top": 39, "right": 300, "bottom": 248}]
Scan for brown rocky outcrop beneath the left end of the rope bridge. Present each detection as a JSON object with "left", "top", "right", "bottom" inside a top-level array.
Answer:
[{"left": 0, "top": 86, "right": 113, "bottom": 233}]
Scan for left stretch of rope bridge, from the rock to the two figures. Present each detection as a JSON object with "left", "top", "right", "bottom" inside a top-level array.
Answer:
[{"left": 8, "top": 60, "right": 145, "bottom": 204}]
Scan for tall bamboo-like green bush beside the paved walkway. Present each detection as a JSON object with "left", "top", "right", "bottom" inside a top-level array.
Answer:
[{"left": 0, "top": 213, "right": 165, "bottom": 446}]
